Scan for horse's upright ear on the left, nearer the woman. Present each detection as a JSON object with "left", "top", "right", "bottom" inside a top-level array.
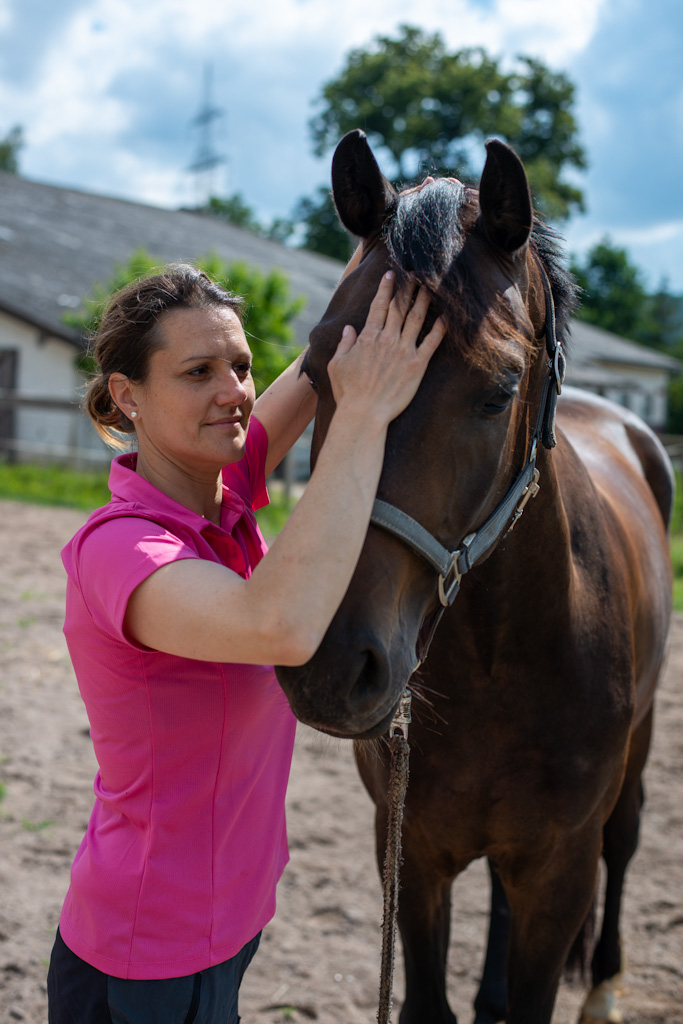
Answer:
[{"left": 332, "top": 128, "right": 396, "bottom": 239}]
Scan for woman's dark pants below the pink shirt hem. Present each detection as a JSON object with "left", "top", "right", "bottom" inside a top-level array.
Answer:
[{"left": 47, "top": 930, "right": 261, "bottom": 1024}]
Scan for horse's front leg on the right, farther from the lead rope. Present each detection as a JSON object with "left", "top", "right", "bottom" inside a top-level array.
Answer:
[{"left": 499, "top": 821, "right": 602, "bottom": 1024}]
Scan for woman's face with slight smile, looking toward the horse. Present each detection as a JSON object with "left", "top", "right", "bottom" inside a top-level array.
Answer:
[{"left": 135, "top": 306, "right": 255, "bottom": 473}]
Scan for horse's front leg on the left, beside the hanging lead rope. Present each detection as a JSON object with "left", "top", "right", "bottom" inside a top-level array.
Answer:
[{"left": 377, "top": 814, "right": 458, "bottom": 1024}]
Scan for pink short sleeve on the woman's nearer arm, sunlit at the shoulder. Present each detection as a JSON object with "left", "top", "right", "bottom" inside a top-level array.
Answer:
[{"left": 71, "top": 516, "right": 200, "bottom": 640}]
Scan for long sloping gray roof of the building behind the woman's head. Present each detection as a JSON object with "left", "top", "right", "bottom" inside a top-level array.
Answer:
[{"left": 0, "top": 172, "right": 342, "bottom": 352}]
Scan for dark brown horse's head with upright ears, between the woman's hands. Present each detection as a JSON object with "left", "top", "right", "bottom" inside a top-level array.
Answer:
[{"left": 278, "top": 132, "right": 573, "bottom": 736}]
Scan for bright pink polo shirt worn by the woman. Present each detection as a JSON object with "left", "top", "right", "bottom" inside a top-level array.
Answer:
[{"left": 59, "top": 420, "right": 295, "bottom": 979}]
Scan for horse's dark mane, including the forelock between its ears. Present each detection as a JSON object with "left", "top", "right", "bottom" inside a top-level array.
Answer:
[{"left": 383, "top": 178, "right": 577, "bottom": 370}]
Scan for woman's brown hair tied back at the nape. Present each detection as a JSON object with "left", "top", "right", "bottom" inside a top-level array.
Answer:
[{"left": 84, "top": 263, "right": 244, "bottom": 449}]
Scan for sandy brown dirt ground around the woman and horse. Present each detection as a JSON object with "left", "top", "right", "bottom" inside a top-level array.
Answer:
[{"left": 0, "top": 502, "right": 683, "bottom": 1024}]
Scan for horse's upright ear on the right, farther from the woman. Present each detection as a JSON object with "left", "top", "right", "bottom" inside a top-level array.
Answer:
[{"left": 479, "top": 138, "right": 533, "bottom": 253}]
